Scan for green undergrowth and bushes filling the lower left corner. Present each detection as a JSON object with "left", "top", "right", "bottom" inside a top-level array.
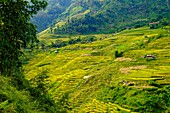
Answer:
[{"left": 0, "top": 71, "right": 64, "bottom": 113}]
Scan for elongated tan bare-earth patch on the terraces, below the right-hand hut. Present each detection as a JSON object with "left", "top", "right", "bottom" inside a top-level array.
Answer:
[{"left": 120, "top": 66, "right": 147, "bottom": 74}]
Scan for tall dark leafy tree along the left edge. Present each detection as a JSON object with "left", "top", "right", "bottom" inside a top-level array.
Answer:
[{"left": 0, "top": 0, "right": 47, "bottom": 76}]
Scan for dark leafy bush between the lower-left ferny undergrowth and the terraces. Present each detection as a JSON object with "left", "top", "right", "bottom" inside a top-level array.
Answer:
[{"left": 29, "top": 71, "right": 59, "bottom": 113}]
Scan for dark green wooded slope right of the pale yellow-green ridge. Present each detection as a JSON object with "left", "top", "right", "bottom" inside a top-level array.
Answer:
[{"left": 54, "top": 0, "right": 170, "bottom": 34}]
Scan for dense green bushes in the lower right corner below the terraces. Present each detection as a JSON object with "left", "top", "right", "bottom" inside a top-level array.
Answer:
[{"left": 98, "top": 86, "right": 170, "bottom": 113}]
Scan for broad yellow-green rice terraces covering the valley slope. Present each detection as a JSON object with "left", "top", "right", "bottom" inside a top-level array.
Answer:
[{"left": 24, "top": 26, "right": 170, "bottom": 113}]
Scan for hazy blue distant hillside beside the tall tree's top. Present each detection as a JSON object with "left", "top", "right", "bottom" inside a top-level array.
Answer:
[{"left": 31, "top": 0, "right": 71, "bottom": 32}]
